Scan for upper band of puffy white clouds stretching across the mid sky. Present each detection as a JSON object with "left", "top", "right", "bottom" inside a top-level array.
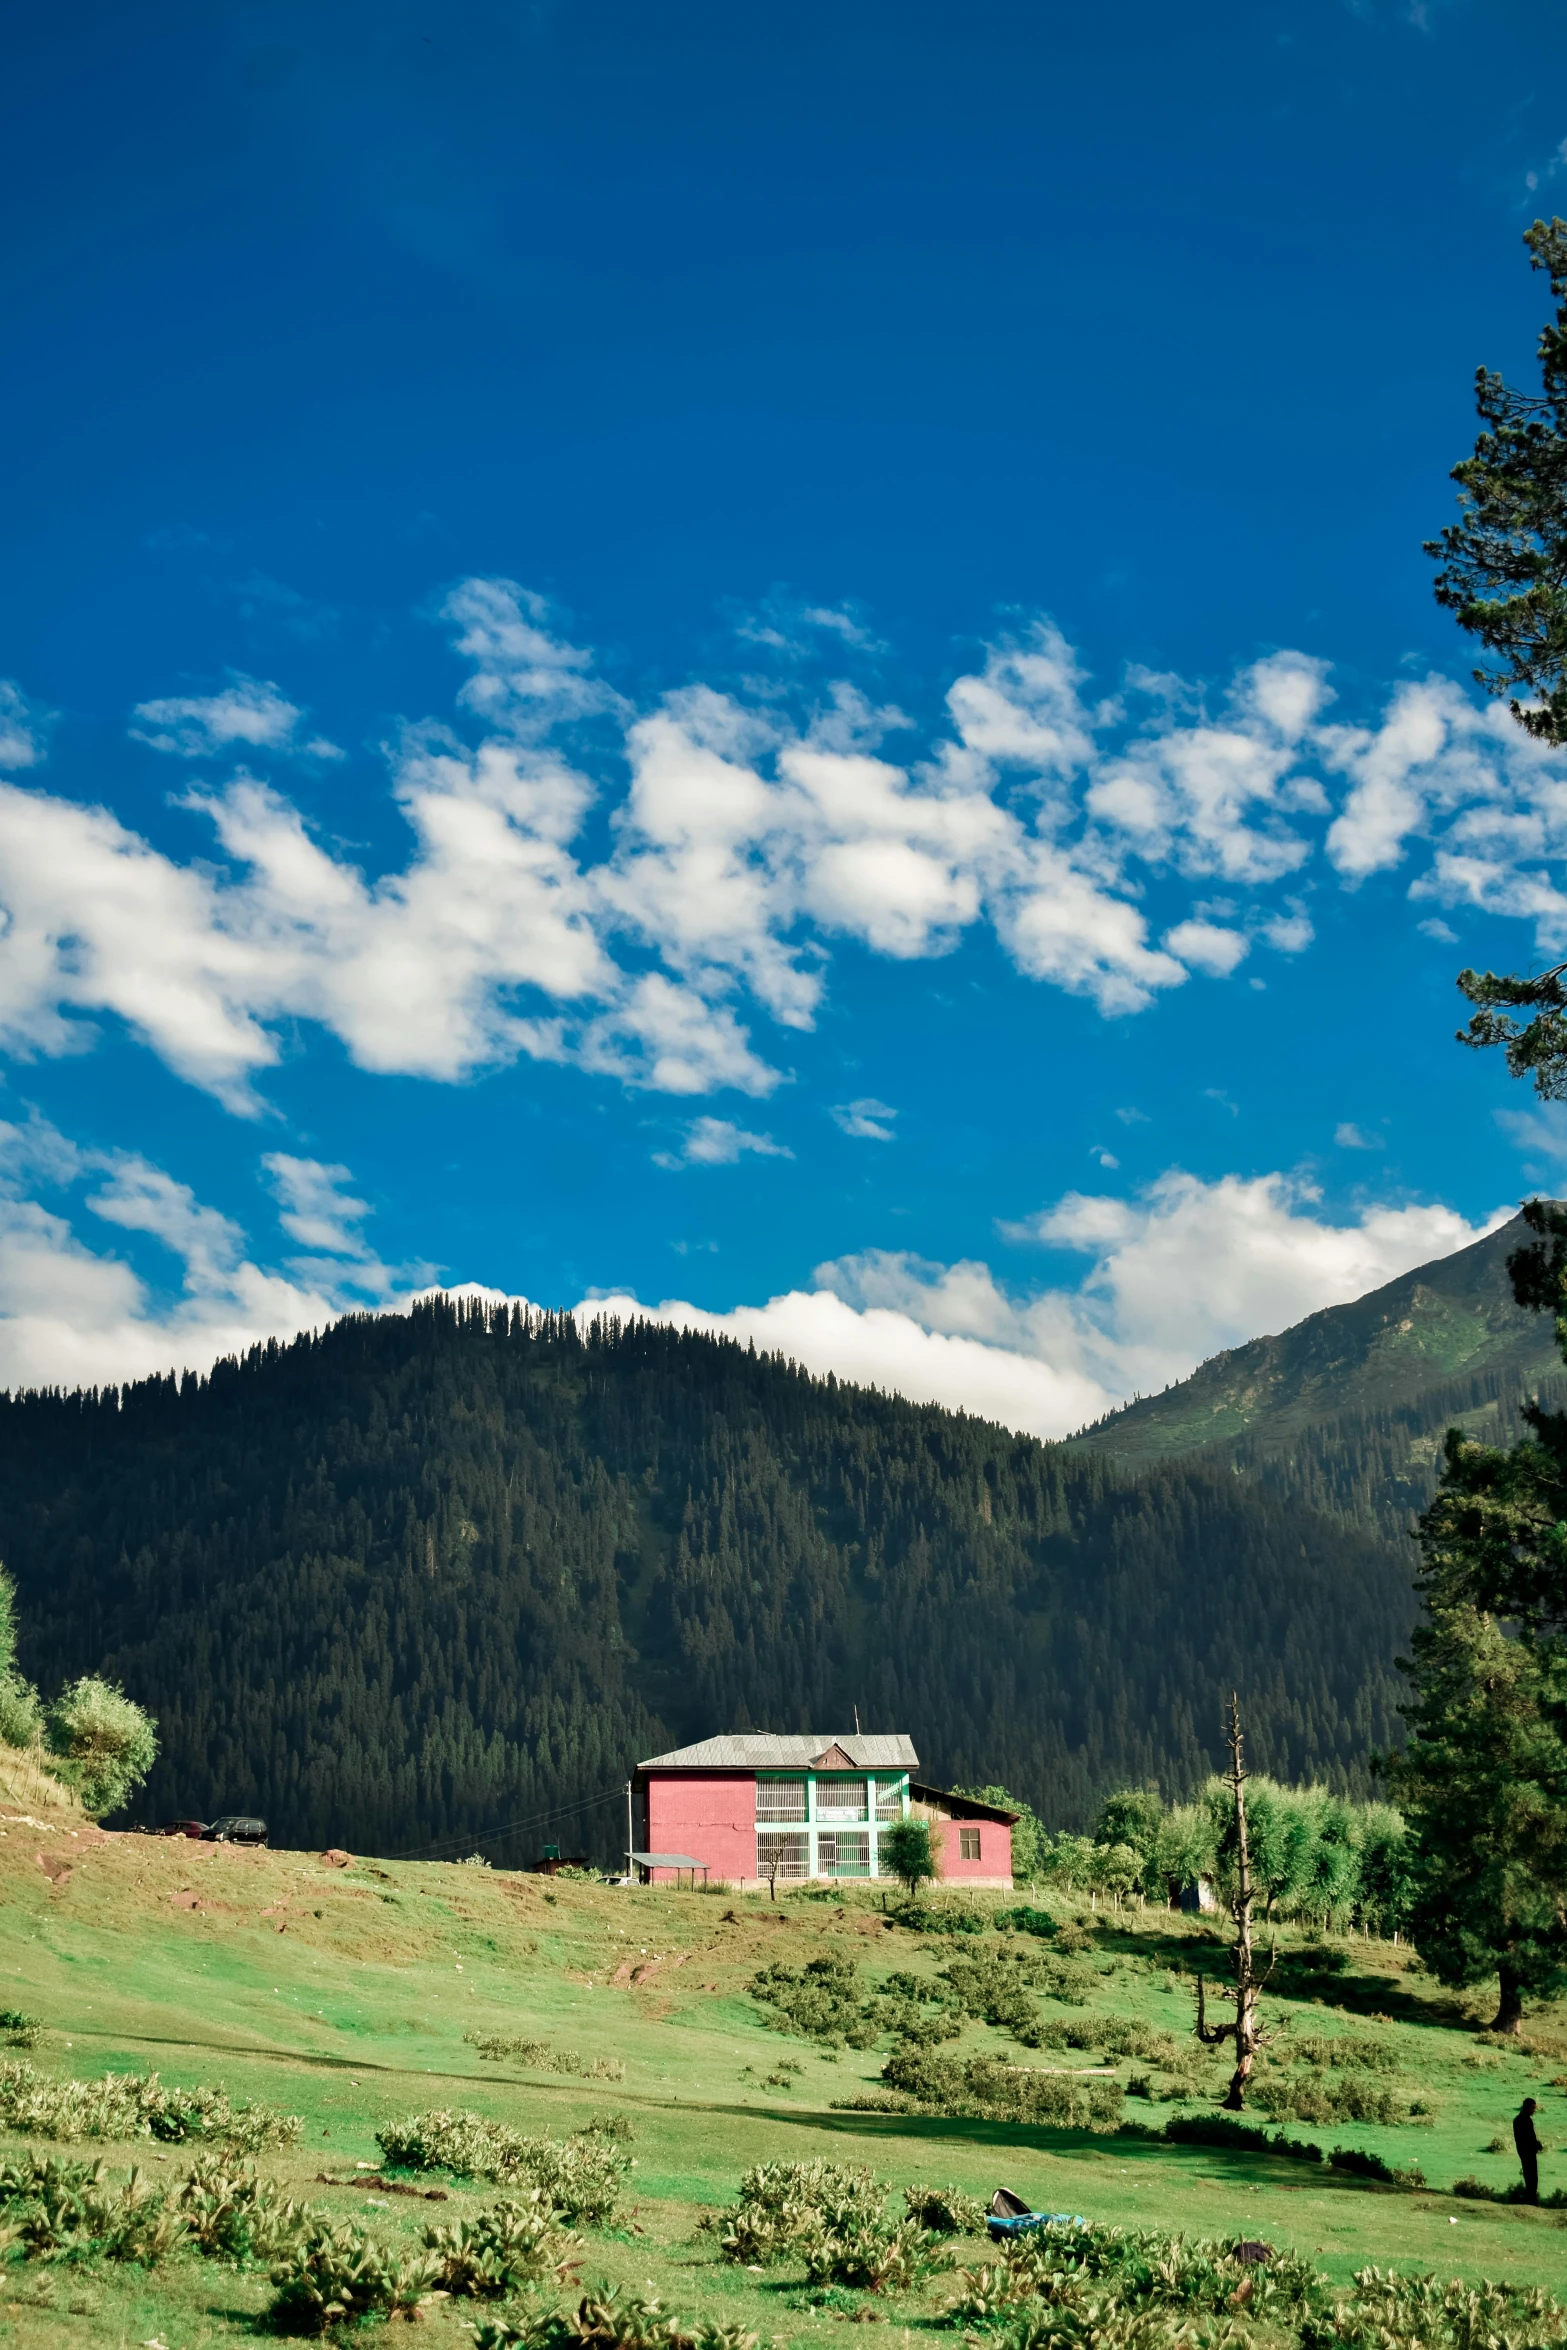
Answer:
[{"left": 0, "top": 578, "right": 1567, "bottom": 1109}]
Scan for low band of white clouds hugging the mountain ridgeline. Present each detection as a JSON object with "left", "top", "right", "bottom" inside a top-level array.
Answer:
[{"left": 0, "top": 1116, "right": 1503, "bottom": 1436}]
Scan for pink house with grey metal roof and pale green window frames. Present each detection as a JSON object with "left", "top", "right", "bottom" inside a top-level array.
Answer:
[{"left": 632, "top": 1730, "right": 1017, "bottom": 1887}]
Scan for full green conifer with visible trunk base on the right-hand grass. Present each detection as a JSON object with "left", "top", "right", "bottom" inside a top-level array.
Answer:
[{"left": 1391, "top": 1597, "right": 1567, "bottom": 2033}]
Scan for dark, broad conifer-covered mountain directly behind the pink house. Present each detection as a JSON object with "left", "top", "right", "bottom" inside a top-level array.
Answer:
[{"left": 0, "top": 1302, "right": 1414, "bottom": 1859}]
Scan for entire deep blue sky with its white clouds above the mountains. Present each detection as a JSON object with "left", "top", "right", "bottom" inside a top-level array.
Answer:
[{"left": 0, "top": 0, "right": 1567, "bottom": 1434}]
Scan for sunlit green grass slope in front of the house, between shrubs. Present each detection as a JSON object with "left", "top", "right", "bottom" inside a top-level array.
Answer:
[{"left": 0, "top": 1810, "right": 1567, "bottom": 2350}]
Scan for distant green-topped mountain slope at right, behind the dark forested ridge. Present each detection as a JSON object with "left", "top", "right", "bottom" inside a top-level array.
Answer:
[{"left": 1074, "top": 1217, "right": 1567, "bottom": 1539}]
